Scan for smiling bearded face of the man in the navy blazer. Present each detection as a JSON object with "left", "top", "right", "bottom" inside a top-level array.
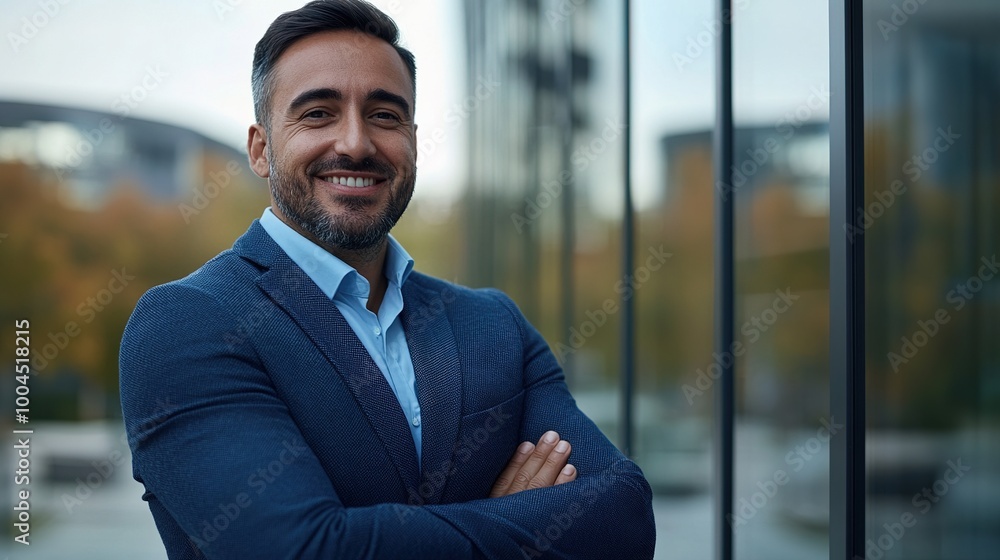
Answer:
[{"left": 250, "top": 31, "right": 417, "bottom": 250}]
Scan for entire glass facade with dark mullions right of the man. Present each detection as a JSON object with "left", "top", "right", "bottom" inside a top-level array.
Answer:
[{"left": 463, "top": 0, "right": 1000, "bottom": 560}]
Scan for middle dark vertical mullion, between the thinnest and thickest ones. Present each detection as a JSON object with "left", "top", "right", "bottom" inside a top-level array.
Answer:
[{"left": 713, "top": 0, "right": 735, "bottom": 560}]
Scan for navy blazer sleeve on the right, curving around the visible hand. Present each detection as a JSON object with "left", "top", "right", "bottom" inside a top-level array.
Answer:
[{"left": 418, "top": 290, "right": 656, "bottom": 560}]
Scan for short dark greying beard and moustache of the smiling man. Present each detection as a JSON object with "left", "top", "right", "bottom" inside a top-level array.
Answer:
[{"left": 269, "top": 152, "right": 416, "bottom": 252}]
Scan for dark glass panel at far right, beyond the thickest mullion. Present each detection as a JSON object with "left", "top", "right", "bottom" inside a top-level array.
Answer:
[{"left": 860, "top": 0, "right": 1000, "bottom": 560}]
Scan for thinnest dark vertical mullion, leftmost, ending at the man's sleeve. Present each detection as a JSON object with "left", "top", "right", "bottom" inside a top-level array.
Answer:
[{"left": 621, "top": 0, "right": 635, "bottom": 457}]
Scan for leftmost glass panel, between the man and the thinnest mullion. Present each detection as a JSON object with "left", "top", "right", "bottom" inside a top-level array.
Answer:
[{"left": 464, "top": 0, "right": 625, "bottom": 443}]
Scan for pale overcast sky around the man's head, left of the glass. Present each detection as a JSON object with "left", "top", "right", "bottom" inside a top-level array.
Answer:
[{"left": 0, "top": 0, "right": 464, "bottom": 201}]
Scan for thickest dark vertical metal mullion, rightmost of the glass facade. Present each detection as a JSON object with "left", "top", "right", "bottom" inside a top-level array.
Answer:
[{"left": 830, "top": 0, "right": 865, "bottom": 560}]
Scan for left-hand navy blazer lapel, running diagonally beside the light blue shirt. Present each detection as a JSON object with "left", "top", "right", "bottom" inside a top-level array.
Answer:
[{"left": 234, "top": 221, "right": 423, "bottom": 490}]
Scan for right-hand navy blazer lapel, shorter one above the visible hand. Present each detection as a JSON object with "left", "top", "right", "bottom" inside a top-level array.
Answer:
[{"left": 403, "top": 279, "right": 462, "bottom": 504}]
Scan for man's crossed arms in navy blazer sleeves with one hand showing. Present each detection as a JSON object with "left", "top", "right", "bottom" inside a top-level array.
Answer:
[{"left": 121, "top": 284, "right": 655, "bottom": 560}]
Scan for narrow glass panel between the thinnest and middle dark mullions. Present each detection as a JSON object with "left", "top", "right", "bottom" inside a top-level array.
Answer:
[{"left": 632, "top": 0, "right": 715, "bottom": 560}]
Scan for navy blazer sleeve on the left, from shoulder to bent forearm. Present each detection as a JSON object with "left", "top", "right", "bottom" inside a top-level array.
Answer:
[{"left": 120, "top": 284, "right": 482, "bottom": 560}]
